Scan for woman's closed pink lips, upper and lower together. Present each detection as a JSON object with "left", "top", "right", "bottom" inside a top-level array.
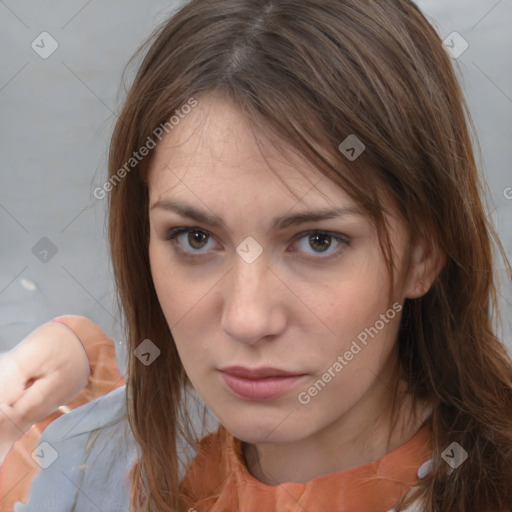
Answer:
[{"left": 220, "top": 366, "right": 304, "bottom": 401}]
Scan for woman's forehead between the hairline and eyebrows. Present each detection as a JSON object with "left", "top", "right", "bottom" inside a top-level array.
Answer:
[{"left": 148, "top": 95, "right": 355, "bottom": 207}]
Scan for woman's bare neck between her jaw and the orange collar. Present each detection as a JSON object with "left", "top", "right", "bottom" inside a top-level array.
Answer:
[{"left": 243, "top": 383, "right": 431, "bottom": 485}]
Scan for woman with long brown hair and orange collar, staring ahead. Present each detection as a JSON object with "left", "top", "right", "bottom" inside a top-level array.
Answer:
[{"left": 1, "top": 0, "right": 512, "bottom": 512}]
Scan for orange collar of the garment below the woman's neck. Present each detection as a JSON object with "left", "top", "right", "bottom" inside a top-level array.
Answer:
[{"left": 182, "top": 426, "right": 431, "bottom": 512}]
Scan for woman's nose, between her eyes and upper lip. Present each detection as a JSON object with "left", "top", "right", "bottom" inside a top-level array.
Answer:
[{"left": 221, "top": 255, "right": 287, "bottom": 345}]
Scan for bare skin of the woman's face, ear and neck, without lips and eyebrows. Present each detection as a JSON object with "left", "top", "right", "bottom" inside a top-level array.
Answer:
[{"left": 148, "top": 96, "right": 439, "bottom": 485}]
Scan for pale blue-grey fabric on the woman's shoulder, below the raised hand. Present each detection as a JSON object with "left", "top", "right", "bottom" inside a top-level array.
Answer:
[{"left": 14, "top": 386, "right": 138, "bottom": 512}]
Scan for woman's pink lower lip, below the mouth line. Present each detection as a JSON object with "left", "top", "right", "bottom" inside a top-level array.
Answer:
[{"left": 222, "top": 372, "right": 304, "bottom": 401}]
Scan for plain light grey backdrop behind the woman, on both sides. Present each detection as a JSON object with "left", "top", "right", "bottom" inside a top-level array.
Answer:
[{"left": 0, "top": 0, "right": 512, "bottom": 374}]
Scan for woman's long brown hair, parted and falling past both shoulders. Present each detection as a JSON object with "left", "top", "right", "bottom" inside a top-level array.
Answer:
[{"left": 109, "top": 0, "right": 512, "bottom": 512}]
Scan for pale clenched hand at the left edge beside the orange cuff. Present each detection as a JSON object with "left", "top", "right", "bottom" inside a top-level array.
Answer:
[{"left": 0, "top": 322, "right": 90, "bottom": 464}]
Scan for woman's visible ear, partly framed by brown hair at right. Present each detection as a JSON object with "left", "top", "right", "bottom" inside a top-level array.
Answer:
[{"left": 404, "top": 239, "right": 446, "bottom": 299}]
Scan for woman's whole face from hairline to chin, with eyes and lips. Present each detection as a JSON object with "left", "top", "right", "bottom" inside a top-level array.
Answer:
[{"left": 149, "top": 96, "right": 422, "bottom": 443}]
